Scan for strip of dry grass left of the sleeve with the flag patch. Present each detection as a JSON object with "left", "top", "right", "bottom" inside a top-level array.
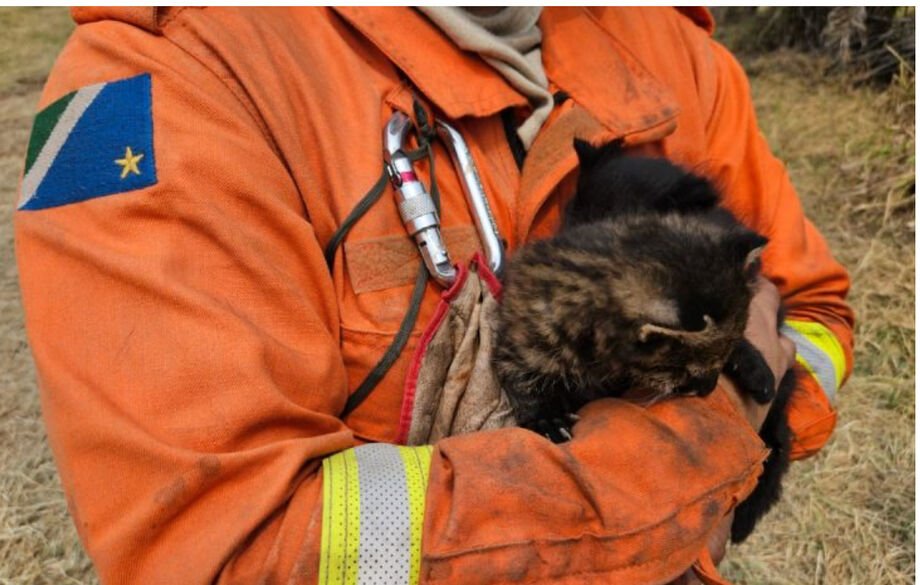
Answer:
[{"left": 0, "top": 8, "right": 96, "bottom": 585}]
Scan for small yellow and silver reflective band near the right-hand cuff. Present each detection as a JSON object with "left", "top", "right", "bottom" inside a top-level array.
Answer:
[{"left": 783, "top": 320, "right": 846, "bottom": 398}]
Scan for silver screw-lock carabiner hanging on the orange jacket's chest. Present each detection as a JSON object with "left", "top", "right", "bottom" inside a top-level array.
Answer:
[{"left": 383, "top": 112, "right": 504, "bottom": 288}]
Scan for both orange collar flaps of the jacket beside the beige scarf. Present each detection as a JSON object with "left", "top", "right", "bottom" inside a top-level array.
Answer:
[{"left": 335, "top": 7, "right": 677, "bottom": 136}]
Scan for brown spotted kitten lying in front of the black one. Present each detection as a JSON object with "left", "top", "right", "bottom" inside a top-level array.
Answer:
[{"left": 495, "top": 214, "right": 763, "bottom": 422}]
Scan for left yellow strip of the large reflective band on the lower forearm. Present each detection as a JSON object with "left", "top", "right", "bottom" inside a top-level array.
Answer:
[{"left": 319, "top": 449, "right": 361, "bottom": 585}]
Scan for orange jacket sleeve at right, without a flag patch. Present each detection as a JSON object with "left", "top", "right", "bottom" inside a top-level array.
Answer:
[{"left": 706, "top": 41, "right": 853, "bottom": 458}]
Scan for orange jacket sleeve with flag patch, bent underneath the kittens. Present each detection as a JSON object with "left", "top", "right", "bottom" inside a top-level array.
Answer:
[{"left": 15, "top": 14, "right": 768, "bottom": 584}]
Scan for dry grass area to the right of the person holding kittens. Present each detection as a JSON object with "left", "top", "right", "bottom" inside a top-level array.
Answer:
[{"left": 725, "top": 53, "right": 915, "bottom": 585}]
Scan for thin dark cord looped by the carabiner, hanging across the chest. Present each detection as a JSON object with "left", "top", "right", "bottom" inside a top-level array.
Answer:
[{"left": 325, "top": 114, "right": 441, "bottom": 418}]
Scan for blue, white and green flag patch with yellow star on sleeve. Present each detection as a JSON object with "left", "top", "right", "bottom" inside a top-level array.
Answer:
[{"left": 19, "top": 73, "right": 157, "bottom": 210}]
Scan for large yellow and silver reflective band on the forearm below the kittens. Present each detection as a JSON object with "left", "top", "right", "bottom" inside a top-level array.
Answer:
[{"left": 319, "top": 443, "right": 432, "bottom": 585}]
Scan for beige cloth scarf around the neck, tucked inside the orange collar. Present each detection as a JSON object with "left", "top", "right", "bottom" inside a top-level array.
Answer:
[{"left": 418, "top": 6, "right": 553, "bottom": 149}]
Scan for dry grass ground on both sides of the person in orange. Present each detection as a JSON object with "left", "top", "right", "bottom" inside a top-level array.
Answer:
[{"left": 0, "top": 8, "right": 915, "bottom": 585}]
